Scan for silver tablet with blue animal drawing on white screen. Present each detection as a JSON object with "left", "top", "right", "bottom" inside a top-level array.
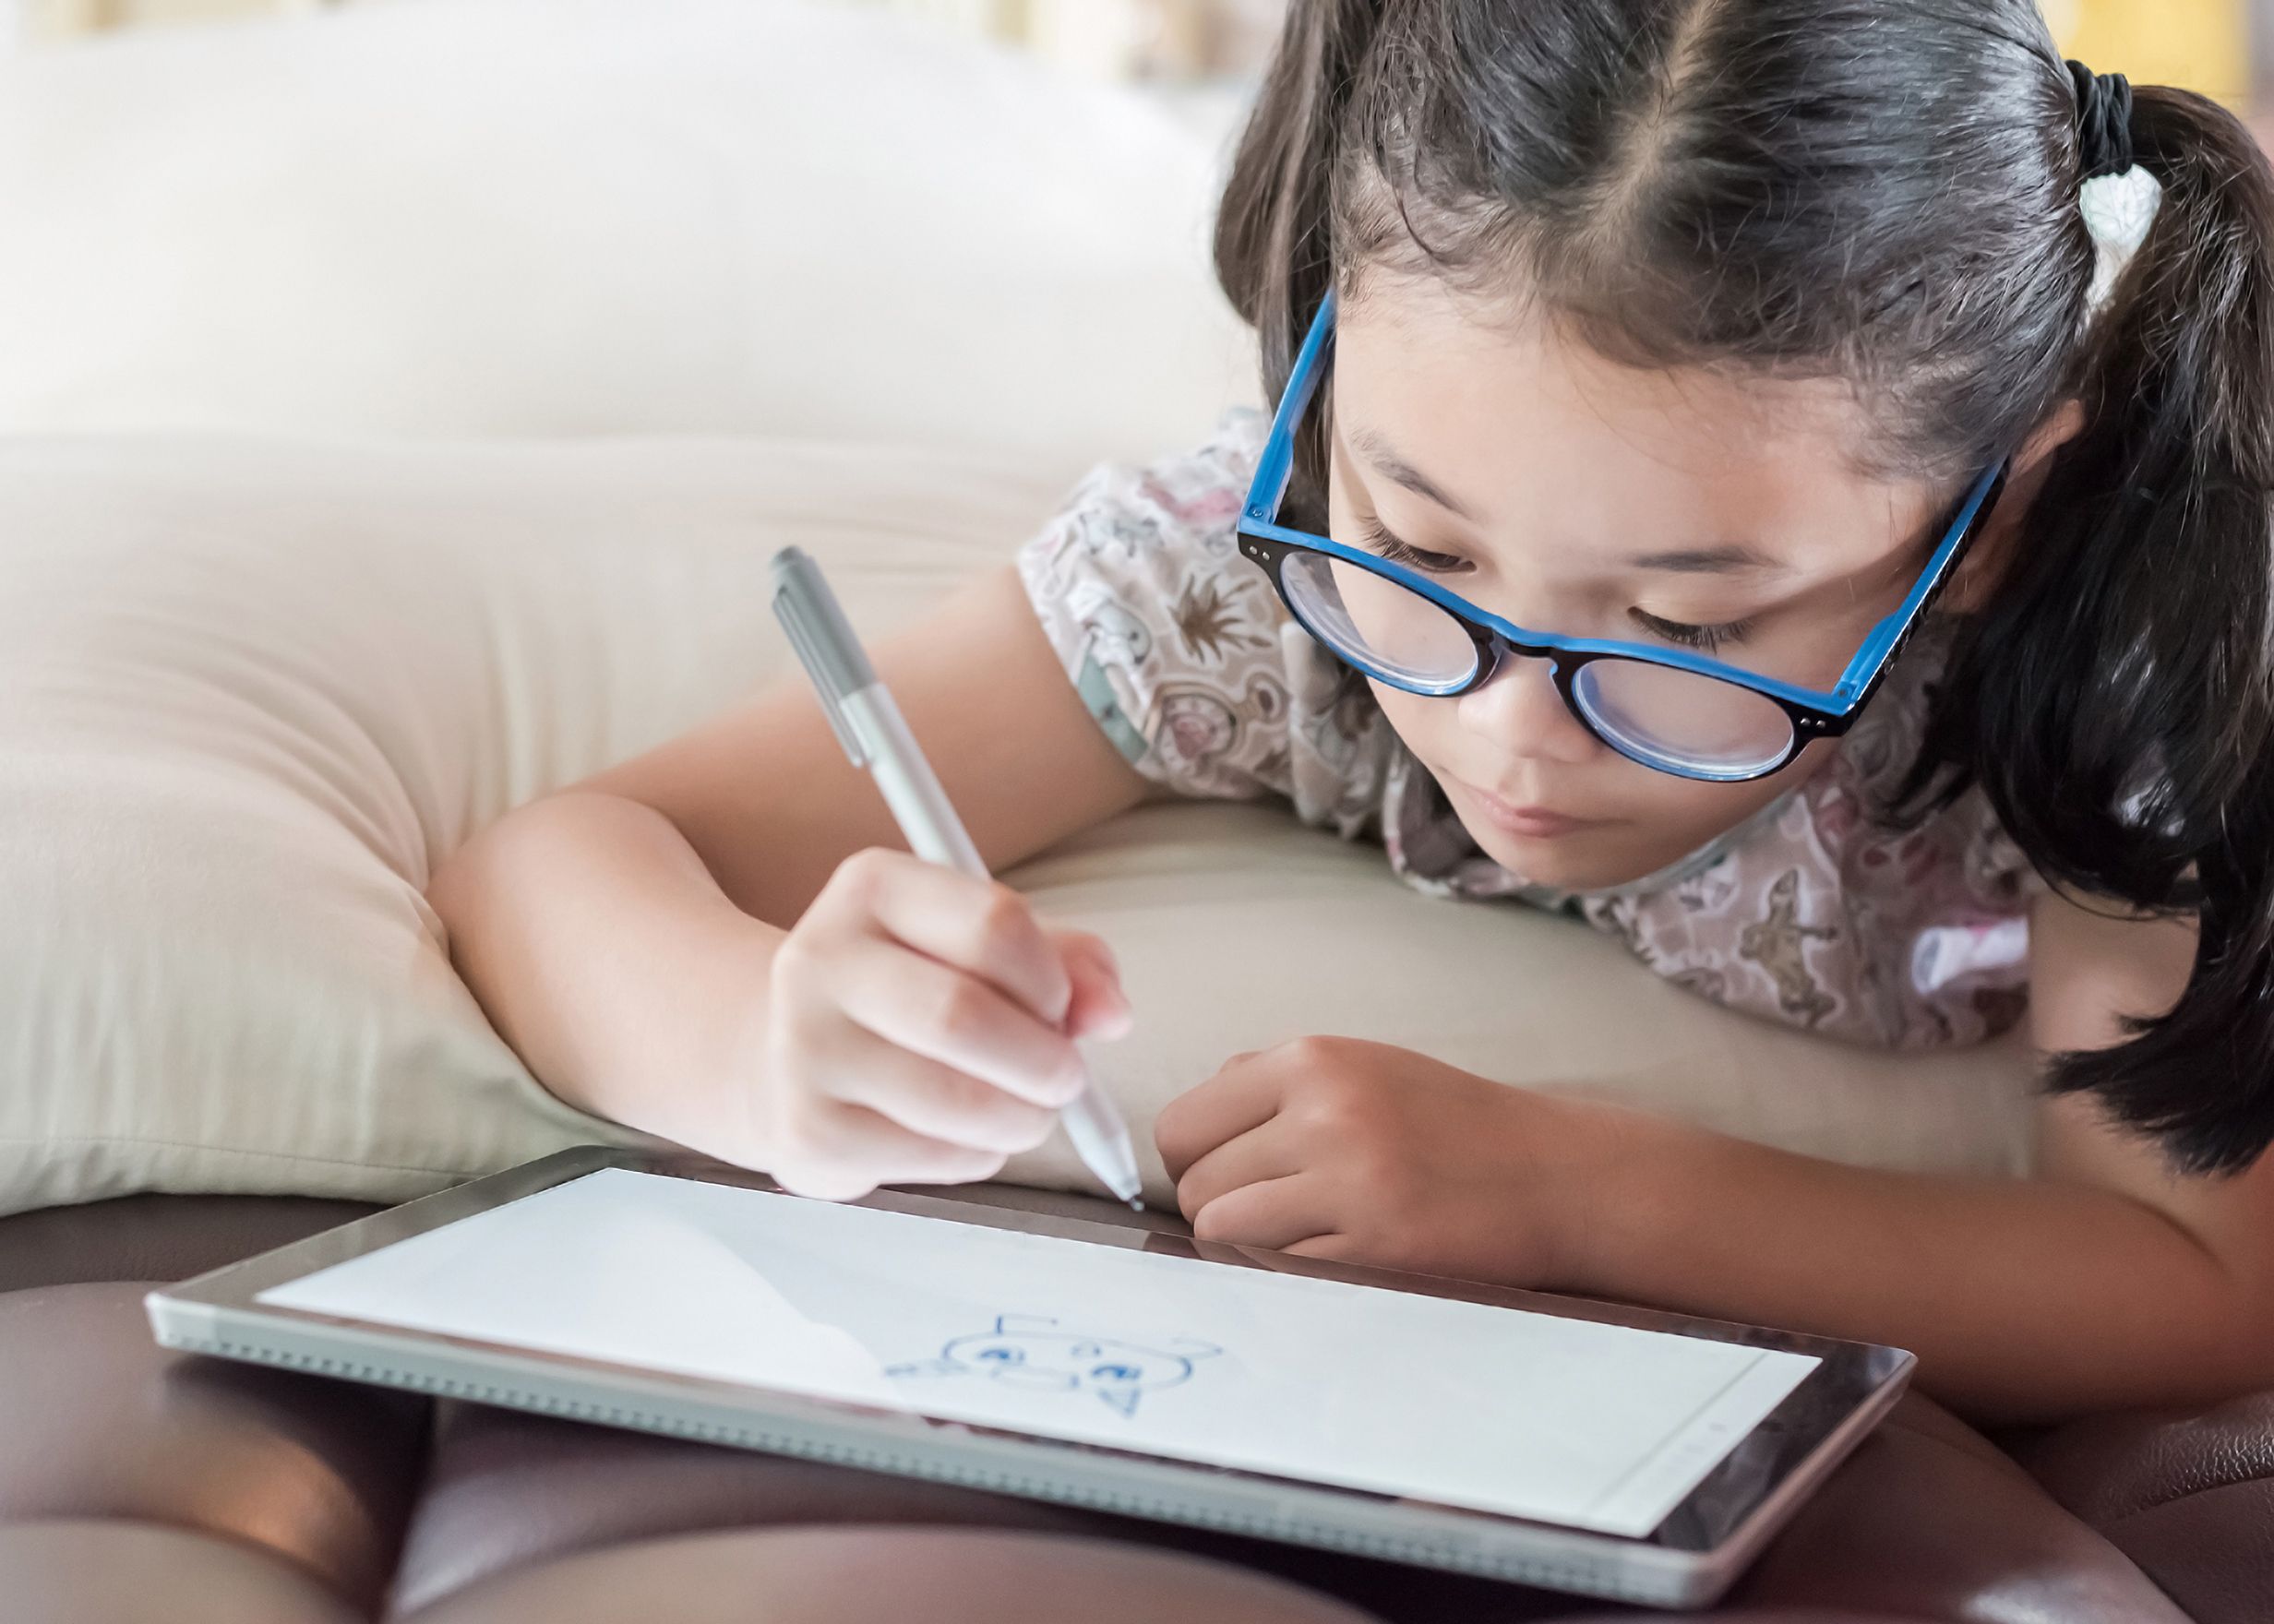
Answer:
[{"left": 148, "top": 1149, "right": 1912, "bottom": 1606}]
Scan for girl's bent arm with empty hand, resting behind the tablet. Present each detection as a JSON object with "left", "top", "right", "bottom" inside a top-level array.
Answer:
[{"left": 1162, "top": 899, "right": 2274, "bottom": 1422}]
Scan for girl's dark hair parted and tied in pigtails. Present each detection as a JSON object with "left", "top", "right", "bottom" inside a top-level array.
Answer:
[{"left": 1216, "top": 0, "right": 2274, "bottom": 1171}]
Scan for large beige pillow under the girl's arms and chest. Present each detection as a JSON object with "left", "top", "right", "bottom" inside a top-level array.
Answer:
[{"left": 0, "top": 439, "right": 2029, "bottom": 1212}]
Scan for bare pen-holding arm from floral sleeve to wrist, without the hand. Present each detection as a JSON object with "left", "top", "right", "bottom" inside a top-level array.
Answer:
[{"left": 427, "top": 568, "right": 1143, "bottom": 1167}]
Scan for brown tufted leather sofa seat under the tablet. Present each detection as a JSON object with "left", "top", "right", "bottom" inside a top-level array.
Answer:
[{"left": 0, "top": 1192, "right": 2274, "bottom": 1624}]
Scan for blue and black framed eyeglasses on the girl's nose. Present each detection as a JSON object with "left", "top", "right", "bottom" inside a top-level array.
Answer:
[{"left": 1237, "top": 293, "right": 2008, "bottom": 784}]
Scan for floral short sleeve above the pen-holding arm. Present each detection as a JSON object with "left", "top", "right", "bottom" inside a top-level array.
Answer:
[{"left": 1019, "top": 412, "right": 1312, "bottom": 801}]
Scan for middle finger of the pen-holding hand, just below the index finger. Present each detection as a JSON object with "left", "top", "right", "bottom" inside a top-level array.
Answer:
[{"left": 837, "top": 942, "right": 1087, "bottom": 1110}]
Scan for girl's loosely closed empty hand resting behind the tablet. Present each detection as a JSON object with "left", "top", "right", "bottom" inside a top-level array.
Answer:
[{"left": 1153, "top": 1037, "right": 1622, "bottom": 1287}]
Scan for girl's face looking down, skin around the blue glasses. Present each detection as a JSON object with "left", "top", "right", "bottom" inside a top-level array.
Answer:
[{"left": 1328, "top": 275, "right": 1958, "bottom": 890}]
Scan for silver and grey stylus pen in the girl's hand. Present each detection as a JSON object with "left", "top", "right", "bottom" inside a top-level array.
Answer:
[{"left": 773, "top": 546, "right": 1143, "bottom": 1210}]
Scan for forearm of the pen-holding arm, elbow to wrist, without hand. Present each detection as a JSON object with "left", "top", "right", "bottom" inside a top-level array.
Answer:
[{"left": 427, "top": 794, "right": 783, "bottom": 1141}]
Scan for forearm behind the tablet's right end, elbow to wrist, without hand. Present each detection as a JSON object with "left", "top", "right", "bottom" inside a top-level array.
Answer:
[{"left": 1572, "top": 1119, "right": 2274, "bottom": 1422}]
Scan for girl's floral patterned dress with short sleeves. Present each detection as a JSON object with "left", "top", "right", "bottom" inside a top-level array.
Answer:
[{"left": 1019, "top": 412, "right": 2040, "bottom": 1048}]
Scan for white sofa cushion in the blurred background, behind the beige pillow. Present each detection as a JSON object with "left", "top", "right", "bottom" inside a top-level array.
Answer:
[{"left": 0, "top": 0, "right": 1255, "bottom": 480}]
